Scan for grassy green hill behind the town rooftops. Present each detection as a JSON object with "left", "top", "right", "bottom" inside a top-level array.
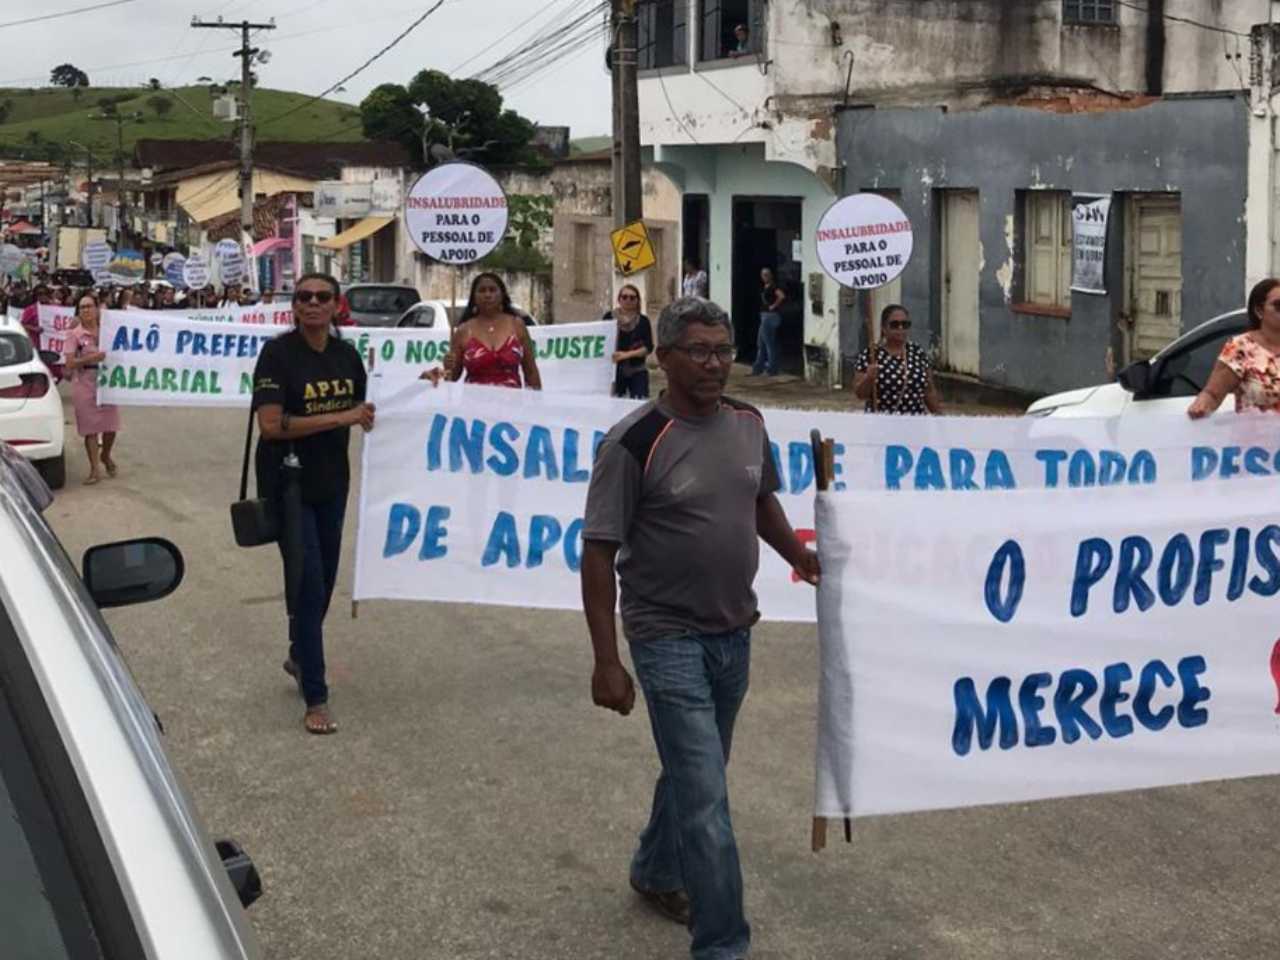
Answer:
[{"left": 0, "top": 87, "right": 364, "bottom": 163}]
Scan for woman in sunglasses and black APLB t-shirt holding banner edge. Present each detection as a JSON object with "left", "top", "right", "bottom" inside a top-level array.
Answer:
[{"left": 253, "top": 274, "right": 374, "bottom": 733}]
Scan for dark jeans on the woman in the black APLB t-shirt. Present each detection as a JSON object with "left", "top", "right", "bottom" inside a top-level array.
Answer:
[{"left": 282, "top": 493, "right": 347, "bottom": 707}]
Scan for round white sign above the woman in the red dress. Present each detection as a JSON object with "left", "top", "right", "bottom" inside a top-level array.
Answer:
[{"left": 404, "top": 161, "right": 508, "bottom": 264}]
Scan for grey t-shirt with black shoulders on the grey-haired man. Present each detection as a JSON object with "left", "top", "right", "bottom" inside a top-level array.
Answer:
[{"left": 582, "top": 397, "right": 782, "bottom": 641}]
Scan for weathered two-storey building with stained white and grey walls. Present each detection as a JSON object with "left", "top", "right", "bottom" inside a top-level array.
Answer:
[{"left": 640, "top": 0, "right": 1274, "bottom": 392}]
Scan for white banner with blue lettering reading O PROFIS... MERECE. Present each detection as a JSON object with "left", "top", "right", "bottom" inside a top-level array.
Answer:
[{"left": 815, "top": 481, "right": 1280, "bottom": 817}]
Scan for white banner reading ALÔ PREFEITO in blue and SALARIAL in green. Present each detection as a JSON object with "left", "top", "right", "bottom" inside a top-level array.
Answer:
[{"left": 93, "top": 310, "right": 617, "bottom": 407}]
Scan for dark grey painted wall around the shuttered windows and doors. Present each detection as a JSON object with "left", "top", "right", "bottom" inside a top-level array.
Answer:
[{"left": 838, "top": 95, "right": 1249, "bottom": 393}]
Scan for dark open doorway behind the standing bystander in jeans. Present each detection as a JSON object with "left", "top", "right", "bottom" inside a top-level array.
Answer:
[{"left": 727, "top": 197, "right": 804, "bottom": 376}]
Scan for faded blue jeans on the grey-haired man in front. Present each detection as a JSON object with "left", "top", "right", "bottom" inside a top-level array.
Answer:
[{"left": 631, "top": 630, "right": 751, "bottom": 960}]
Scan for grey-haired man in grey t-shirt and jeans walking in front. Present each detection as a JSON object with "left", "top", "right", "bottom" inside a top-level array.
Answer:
[{"left": 582, "top": 298, "right": 818, "bottom": 960}]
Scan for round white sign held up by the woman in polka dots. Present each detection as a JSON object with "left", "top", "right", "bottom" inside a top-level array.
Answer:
[{"left": 818, "top": 193, "right": 914, "bottom": 291}]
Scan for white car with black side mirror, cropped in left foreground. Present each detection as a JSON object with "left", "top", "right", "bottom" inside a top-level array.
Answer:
[{"left": 0, "top": 443, "right": 261, "bottom": 960}]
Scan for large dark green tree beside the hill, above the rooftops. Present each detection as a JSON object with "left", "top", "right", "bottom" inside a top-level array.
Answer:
[{"left": 360, "top": 70, "right": 541, "bottom": 165}]
